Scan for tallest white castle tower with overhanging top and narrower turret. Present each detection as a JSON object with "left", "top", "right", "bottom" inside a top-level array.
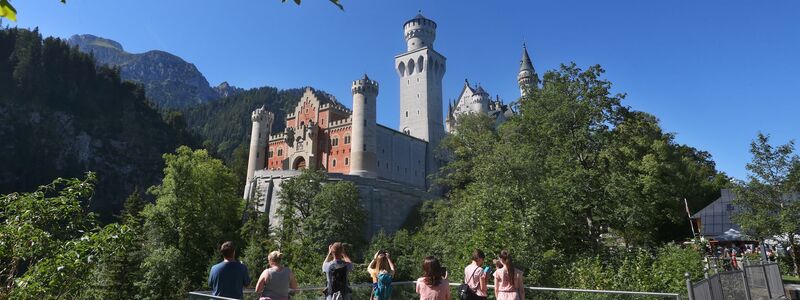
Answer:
[{"left": 394, "top": 14, "right": 446, "bottom": 183}]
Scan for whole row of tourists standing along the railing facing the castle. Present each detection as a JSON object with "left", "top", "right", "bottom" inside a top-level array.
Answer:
[{"left": 208, "top": 242, "right": 525, "bottom": 300}]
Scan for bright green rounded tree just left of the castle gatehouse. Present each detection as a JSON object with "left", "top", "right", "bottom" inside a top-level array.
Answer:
[{"left": 138, "top": 146, "right": 243, "bottom": 299}]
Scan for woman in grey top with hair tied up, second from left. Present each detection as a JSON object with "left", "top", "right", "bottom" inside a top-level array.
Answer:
[{"left": 256, "top": 251, "right": 298, "bottom": 300}]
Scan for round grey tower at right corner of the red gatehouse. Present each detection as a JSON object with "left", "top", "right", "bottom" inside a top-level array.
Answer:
[{"left": 350, "top": 74, "right": 378, "bottom": 178}]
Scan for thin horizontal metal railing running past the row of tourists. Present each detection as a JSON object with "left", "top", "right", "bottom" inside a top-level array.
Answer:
[{"left": 189, "top": 281, "right": 681, "bottom": 300}]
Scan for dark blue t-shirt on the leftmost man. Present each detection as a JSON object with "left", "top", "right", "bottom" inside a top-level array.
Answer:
[{"left": 208, "top": 261, "right": 250, "bottom": 299}]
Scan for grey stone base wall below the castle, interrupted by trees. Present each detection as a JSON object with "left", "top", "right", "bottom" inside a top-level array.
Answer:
[{"left": 251, "top": 170, "right": 433, "bottom": 239}]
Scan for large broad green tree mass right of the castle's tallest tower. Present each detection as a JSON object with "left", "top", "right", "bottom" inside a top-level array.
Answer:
[{"left": 424, "top": 64, "right": 727, "bottom": 285}]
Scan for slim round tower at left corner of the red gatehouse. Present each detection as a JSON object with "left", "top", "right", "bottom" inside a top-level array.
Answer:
[{"left": 244, "top": 106, "right": 275, "bottom": 199}]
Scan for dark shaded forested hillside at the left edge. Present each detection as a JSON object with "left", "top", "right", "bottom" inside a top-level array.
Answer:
[{"left": 0, "top": 29, "right": 199, "bottom": 220}]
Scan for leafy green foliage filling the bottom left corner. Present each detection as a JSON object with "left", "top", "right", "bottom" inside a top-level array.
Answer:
[{"left": 0, "top": 173, "right": 145, "bottom": 299}]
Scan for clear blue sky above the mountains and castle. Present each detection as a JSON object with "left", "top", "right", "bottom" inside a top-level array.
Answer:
[{"left": 4, "top": 0, "right": 800, "bottom": 178}]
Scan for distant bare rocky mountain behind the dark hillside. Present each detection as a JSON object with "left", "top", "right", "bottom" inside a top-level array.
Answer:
[{"left": 68, "top": 34, "right": 234, "bottom": 109}]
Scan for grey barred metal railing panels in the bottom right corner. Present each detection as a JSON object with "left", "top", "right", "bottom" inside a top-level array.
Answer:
[{"left": 686, "top": 261, "right": 786, "bottom": 300}]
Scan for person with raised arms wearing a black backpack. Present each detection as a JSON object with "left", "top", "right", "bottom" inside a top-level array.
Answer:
[{"left": 322, "top": 242, "right": 353, "bottom": 300}]
